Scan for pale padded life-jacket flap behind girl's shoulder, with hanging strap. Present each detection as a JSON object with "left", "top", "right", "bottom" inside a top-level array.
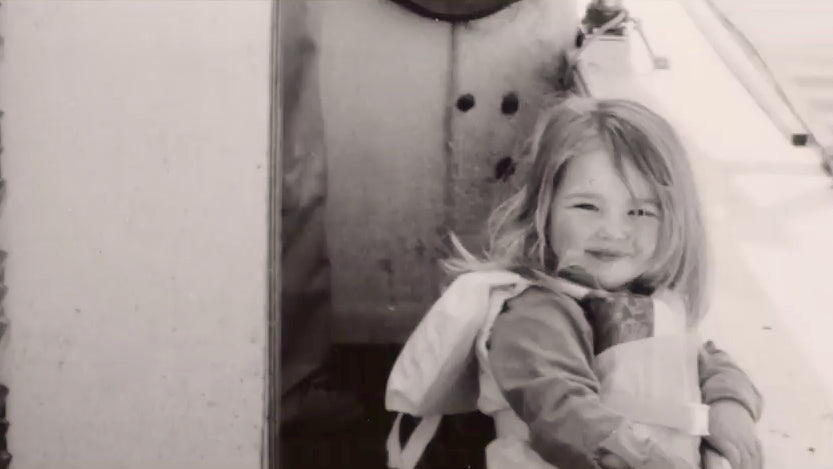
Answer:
[{"left": 385, "top": 271, "right": 530, "bottom": 469}]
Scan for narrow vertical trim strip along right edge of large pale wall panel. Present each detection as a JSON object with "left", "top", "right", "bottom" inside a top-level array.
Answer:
[{"left": 261, "top": 0, "right": 283, "bottom": 469}]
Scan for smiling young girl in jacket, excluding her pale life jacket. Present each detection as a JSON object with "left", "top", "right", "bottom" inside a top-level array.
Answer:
[{"left": 447, "top": 97, "right": 762, "bottom": 469}]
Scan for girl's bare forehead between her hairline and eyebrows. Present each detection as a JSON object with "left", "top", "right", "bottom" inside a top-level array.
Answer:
[{"left": 558, "top": 148, "right": 656, "bottom": 199}]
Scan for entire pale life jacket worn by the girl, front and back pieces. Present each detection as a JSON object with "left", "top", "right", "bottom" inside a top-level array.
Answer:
[{"left": 385, "top": 271, "right": 713, "bottom": 469}]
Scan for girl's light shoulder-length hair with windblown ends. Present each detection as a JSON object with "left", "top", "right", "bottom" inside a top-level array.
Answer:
[{"left": 443, "top": 97, "right": 708, "bottom": 324}]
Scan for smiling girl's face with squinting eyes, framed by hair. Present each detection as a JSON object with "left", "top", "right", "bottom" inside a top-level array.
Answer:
[{"left": 549, "top": 150, "right": 662, "bottom": 290}]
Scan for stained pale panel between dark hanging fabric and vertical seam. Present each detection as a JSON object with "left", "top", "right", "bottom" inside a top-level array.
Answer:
[{"left": 313, "top": 0, "right": 451, "bottom": 342}]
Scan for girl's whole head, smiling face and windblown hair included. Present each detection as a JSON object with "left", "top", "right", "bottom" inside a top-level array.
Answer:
[{"left": 445, "top": 96, "right": 709, "bottom": 323}]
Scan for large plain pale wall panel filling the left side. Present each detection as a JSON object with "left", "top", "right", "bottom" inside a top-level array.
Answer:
[{"left": 0, "top": 0, "right": 271, "bottom": 469}]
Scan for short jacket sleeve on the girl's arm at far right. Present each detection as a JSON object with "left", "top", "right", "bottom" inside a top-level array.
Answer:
[{"left": 698, "top": 341, "right": 763, "bottom": 421}]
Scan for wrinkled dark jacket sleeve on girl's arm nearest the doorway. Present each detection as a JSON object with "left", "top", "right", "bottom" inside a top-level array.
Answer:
[{"left": 489, "top": 287, "right": 686, "bottom": 469}]
